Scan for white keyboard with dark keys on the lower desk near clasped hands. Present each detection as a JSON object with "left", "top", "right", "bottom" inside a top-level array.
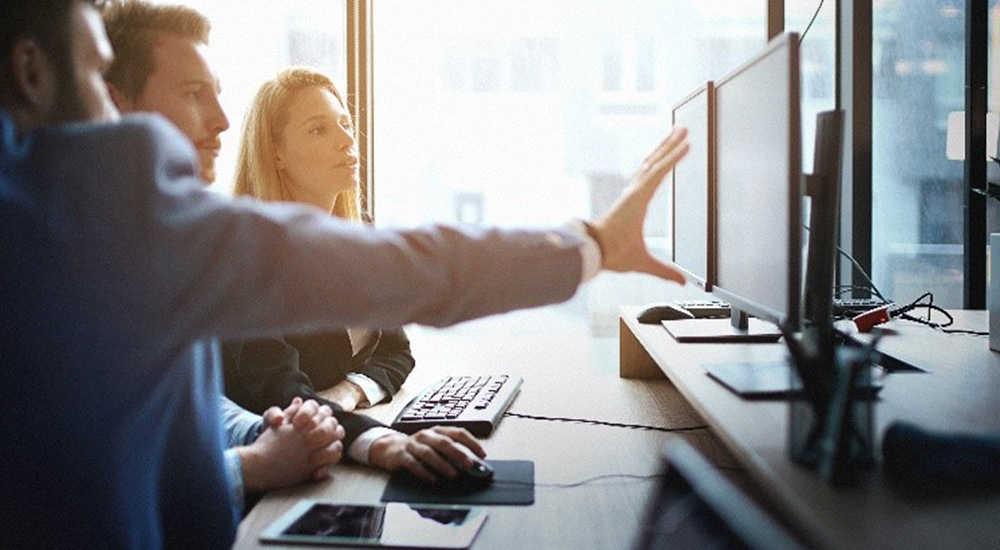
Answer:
[{"left": 390, "top": 374, "right": 522, "bottom": 437}]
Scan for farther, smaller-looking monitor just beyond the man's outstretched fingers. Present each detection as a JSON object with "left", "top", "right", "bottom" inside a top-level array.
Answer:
[{"left": 671, "top": 81, "right": 715, "bottom": 291}]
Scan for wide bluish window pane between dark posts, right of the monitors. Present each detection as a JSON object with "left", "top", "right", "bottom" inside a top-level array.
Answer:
[{"left": 872, "top": 0, "right": 965, "bottom": 307}]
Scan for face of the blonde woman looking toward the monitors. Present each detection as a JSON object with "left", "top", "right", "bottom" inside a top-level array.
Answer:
[{"left": 276, "top": 86, "right": 358, "bottom": 210}]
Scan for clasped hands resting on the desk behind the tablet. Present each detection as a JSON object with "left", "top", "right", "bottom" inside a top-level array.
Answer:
[{"left": 237, "top": 397, "right": 344, "bottom": 493}]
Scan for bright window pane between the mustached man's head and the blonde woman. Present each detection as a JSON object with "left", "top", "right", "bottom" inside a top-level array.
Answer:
[{"left": 143, "top": 0, "right": 347, "bottom": 193}]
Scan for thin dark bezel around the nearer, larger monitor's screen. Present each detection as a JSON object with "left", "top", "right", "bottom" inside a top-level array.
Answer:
[{"left": 712, "top": 33, "right": 803, "bottom": 330}]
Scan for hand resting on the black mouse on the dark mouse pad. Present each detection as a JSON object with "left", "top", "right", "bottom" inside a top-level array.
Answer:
[{"left": 368, "top": 426, "right": 486, "bottom": 483}]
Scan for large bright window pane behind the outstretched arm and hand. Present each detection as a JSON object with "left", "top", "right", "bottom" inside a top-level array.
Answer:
[{"left": 372, "top": 0, "right": 766, "bottom": 376}]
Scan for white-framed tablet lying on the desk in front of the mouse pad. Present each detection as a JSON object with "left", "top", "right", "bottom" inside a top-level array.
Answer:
[{"left": 260, "top": 500, "right": 486, "bottom": 549}]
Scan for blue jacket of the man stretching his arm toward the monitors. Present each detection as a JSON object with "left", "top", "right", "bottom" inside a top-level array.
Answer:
[{"left": 0, "top": 111, "right": 581, "bottom": 549}]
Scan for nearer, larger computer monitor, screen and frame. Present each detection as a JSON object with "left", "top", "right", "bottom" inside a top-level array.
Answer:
[{"left": 712, "top": 33, "right": 803, "bottom": 330}]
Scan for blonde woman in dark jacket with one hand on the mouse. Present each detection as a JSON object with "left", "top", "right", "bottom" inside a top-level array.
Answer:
[{"left": 223, "top": 68, "right": 485, "bottom": 480}]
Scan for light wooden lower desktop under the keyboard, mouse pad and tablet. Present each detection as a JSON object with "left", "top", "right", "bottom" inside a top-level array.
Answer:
[{"left": 235, "top": 360, "right": 740, "bottom": 550}]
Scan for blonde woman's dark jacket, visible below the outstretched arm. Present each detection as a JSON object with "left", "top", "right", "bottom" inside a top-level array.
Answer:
[{"left": 222, "top": 328, "right": 414, "bottom": 447}]
